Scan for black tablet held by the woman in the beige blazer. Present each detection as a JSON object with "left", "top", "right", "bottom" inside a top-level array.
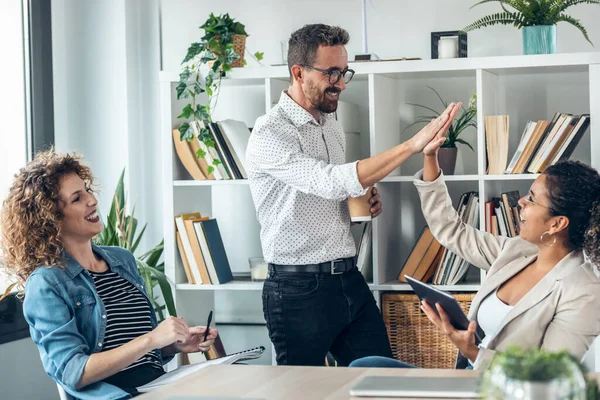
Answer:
[{"left": 404, "top": 275, "right": 485, "bottom": 344}]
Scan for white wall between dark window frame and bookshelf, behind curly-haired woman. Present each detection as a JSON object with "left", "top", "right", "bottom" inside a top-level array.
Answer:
[{"left": 52, "top": 0, "right": 162, "bottom": 251}]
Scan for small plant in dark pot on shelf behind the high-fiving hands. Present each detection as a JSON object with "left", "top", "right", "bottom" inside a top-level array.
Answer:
[{"left": 403, "top": 86, "right": 477, "bottom": 175}]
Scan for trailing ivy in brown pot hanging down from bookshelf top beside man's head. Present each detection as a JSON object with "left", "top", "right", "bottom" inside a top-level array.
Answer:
[{"left": 175, "top": 13, "right": 263, "bottom": 177}]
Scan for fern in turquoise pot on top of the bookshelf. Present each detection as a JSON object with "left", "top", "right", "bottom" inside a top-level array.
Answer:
[{"left": 462, "top": 0, "right": 600, "bottom": 54}]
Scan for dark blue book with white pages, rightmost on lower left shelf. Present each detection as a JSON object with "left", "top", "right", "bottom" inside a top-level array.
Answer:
[{"left": 194, "top": 219, "right": 233, "bottom": 285}]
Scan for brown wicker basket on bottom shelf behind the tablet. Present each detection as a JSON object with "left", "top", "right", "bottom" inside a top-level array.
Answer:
[{"left": 381, "top": 293, "right": 476, "bottom": 368}]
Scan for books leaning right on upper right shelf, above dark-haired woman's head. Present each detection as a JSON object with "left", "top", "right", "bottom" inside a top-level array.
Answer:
[{"left": 505, "top": 113, "right": 590, "bottom": 174}]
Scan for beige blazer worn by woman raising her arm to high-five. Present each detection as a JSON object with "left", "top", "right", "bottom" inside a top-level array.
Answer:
[{"left": 414, "top": 171, "right": 600, "bottom": 369}]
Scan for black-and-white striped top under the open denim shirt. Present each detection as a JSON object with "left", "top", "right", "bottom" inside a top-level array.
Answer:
[{"left": 89, "top": 269, "right": 163, "bottom": 372}]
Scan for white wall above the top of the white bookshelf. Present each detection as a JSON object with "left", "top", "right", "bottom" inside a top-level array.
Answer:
[{"left": 161, "top": 0, "right": 600, "bottom": 71}]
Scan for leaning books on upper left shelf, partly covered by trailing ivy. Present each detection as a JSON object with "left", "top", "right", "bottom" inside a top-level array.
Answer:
[{"left": 173, "top": 119, "right": 250, "bottom": 180}]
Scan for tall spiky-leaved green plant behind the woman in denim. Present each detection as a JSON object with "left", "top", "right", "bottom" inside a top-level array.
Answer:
[{"left": 94, "top": 170, "right": 177, "bottom": 321}]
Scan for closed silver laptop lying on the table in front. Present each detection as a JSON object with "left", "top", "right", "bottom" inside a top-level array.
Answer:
[{"left": 350, "top": 376, "right": 481, "bottom": 399}]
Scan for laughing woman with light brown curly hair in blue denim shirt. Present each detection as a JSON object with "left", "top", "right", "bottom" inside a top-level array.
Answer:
[{"left": 1, "top": 150, "right": 217, "bottom": 399}]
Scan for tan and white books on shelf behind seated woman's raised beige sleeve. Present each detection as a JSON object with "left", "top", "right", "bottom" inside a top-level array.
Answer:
[{"left": 398, "top": 192, "right": 479, "bottom": 285}]
